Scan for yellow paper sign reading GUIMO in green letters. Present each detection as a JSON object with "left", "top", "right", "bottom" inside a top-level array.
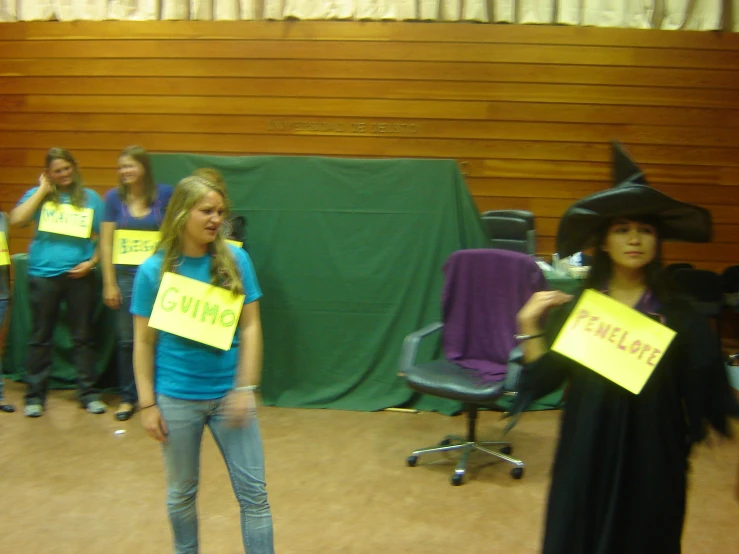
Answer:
[{"left": 149, "top": 272, "right": 244, "bottom": 350}]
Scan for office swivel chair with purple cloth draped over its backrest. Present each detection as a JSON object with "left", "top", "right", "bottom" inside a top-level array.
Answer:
[{"left": 400, "top": 249, "right": 547, "bottom": 485}]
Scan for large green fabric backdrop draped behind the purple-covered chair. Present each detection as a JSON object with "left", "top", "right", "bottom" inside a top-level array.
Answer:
[{"left": 152, "top": 154, "right": 486, "bottom": 412}]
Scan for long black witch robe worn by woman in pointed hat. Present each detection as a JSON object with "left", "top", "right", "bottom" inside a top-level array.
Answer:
[{"left": 517, "top": 292, "right": 739, "bottom": 554}]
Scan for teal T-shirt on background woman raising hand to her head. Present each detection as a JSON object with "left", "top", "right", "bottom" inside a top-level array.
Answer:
[{"left": 17, "top": 187, "right": 105, "bottom": 277}]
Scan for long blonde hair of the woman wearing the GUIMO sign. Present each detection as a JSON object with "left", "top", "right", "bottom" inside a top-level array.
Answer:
[{"left": 158, "top": 175, "right": 244, "bottom": 294}]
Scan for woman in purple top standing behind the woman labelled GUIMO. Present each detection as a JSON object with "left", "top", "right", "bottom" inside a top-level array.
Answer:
[{"left": 100, "top": 146, "right": 172, "bottom": 421}]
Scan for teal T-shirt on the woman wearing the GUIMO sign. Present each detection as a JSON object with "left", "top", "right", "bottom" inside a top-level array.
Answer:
[{"left": 131, "top": 245, "right": 262, "bottom": 400}]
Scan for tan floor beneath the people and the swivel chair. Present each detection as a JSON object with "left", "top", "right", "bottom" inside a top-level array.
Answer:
[{"left": 0, "top": 382, "right": 739, "bottom": 554}]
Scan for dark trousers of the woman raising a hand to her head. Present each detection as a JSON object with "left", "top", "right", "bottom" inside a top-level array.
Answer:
[{"left": 26, "top": 274, "right": 99, "bottom": 406}]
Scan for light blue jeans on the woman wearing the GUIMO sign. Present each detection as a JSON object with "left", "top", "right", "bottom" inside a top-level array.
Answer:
[{"left": 157, "top": 394, "right": 274, "bottom": 554}]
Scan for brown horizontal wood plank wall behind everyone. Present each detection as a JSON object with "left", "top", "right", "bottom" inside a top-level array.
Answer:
[{"left": 0, "top": 21, "right": 739, "bottom": 270}]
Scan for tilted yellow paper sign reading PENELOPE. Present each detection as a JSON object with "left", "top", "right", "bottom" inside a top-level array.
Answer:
[{"left": 552, "top": 289, "right": 675, "bottom": 394}]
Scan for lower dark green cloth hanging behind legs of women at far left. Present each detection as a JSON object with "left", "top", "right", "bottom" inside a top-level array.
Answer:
[{"left": 3, "top": 254, "right": 117, "bottom": 389}]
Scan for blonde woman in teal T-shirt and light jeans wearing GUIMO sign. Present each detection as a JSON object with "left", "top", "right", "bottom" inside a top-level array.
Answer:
[{"left": 131, "top": 176, "right": 274, "bottom": 554}]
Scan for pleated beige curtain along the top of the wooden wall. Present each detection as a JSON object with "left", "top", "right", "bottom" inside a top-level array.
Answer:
[{"left": 0, "top": 0, "right": 739, "bottom": 31}]
